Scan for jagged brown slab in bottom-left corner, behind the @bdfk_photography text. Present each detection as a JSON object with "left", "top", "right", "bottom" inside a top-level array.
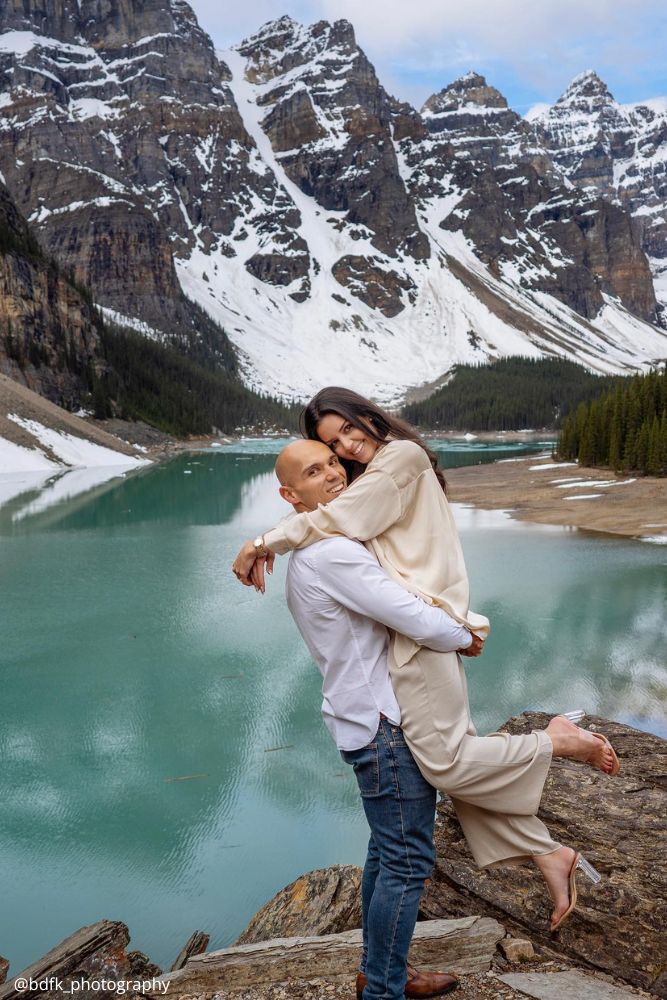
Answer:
[{"left": 0, "top": 920, "right": 146, "bottom": 1000}]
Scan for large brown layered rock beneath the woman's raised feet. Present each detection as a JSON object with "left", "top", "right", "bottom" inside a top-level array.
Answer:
[{"left": 421, "top": 713, "right": 667, "bottom": 997}]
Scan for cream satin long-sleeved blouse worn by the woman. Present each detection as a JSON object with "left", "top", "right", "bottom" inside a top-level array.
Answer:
[{"left": 264, "top": 441, "right": 489, "bottom": 666}]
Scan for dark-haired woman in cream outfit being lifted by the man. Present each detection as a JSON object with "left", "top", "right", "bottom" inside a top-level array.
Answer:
[{"left": 234, "top": 387, "right": 619, "bottom": 930}]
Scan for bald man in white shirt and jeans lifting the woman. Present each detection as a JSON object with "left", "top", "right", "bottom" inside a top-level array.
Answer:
[{"left": 235, "top": 440, "right": 482, "bottom": 1000}]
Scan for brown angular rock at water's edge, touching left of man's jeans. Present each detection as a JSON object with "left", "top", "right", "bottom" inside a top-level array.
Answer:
[{"left": 236, "top": 865, "right": 361, "bottom": 944}]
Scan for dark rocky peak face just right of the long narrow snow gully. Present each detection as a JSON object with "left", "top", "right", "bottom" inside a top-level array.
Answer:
[{"left": 238, "top": 17, "right": 430, "bottom": 270}]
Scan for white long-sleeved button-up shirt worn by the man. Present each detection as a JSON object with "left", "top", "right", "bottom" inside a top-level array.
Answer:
[{"left": 286, "top": 537, "right": 472, "bottom": 750}]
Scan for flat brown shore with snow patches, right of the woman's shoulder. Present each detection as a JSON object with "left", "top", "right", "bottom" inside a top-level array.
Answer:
[{"left": 445, "top": 455, "right": 667, "bottom": 544}]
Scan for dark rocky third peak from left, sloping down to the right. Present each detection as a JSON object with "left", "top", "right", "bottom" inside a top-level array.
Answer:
[{"left": 403, "top": 73, "right": 657, "bottom": 322}]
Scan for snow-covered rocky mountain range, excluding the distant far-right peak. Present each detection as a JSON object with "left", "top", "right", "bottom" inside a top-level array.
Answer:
[{"left": 0, "top": 0, "right": 667, "bottom": 401}]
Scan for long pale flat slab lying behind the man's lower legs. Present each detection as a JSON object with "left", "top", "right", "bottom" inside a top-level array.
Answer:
[{"left": 147, "top": 917, "right": 505, "bottom": 1000}]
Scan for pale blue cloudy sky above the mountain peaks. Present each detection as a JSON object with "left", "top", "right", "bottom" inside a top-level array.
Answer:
[{"left": 190, "top": 0, "right": 667, "bottom": 114}]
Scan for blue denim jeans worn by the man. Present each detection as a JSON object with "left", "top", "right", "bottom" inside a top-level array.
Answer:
[{"left": 341, "top": 719, "right": 436, "bottom": 1000}]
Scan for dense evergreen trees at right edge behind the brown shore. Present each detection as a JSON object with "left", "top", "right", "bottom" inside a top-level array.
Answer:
[{"left": 558, "top": 369, "right": 667, "bottom": 476}]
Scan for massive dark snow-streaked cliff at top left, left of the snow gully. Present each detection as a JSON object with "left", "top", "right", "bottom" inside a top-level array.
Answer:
[{"left": 0, "top": 0, "right": 296, "bottom": 333}]
